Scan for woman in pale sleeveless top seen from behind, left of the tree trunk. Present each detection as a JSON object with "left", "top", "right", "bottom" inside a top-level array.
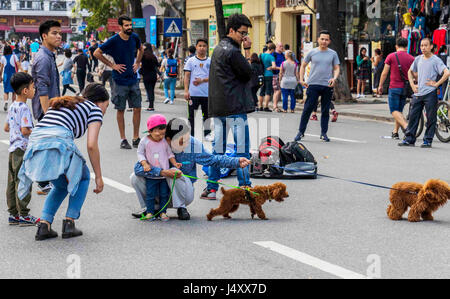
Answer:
[{"left": 279, "top": 50, "right": 300, "bottom": 113}]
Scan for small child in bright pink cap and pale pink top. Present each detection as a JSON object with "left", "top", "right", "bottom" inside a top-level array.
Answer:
[{"left": 137, "top": 114, "right": 182, "bottom": 221}]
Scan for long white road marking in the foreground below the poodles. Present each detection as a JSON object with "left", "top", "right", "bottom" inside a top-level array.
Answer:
[{"left": 253, "top": 241, "right": 367, "bottom": 279}]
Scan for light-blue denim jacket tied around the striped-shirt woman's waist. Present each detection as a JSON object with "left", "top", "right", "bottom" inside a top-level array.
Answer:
[{"left": 18, "top": 126, "right": 86, "bottom": 200}]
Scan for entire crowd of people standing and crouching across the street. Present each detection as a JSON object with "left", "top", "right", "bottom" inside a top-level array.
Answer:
[{"left": 0, "top": 14, "right": 450, "bottom": 240}]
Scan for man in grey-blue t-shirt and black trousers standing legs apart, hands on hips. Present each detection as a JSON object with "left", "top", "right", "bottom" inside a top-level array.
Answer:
[{"left": 295, "top": 31, "right": 340, "bottom": 142}]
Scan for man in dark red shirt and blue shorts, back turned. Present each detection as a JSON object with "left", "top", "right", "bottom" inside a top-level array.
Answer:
[{"left": 378, "top": 37, "right": 414, "bottom": 139}]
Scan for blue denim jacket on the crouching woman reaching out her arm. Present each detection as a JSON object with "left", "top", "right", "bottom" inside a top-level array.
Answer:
[{"left": 134, "top": 136, "right": 239, "bottom": 183}]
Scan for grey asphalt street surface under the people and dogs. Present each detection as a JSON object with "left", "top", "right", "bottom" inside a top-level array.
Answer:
[{"left": 0, "top": 78, "right": 450, "bottom": 279}]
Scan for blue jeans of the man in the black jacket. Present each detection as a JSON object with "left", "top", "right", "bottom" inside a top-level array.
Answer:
[{"left": 207, "top": 114, "right": 252, "bottom": 190}]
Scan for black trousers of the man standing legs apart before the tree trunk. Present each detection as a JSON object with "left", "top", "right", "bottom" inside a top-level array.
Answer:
[{"left": 299, "top": 85, "right": 333, "bottom": 135}]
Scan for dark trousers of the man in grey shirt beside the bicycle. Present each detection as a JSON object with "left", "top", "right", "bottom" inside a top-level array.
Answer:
[{"left": 405, "top": 90, "right": 438, "bottom": 144}]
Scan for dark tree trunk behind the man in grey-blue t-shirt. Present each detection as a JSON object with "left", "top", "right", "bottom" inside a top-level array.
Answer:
[{"left": 316, "top": 0, "right": 353, "bottom": 101}]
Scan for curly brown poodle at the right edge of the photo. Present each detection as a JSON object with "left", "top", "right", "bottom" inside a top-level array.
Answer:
[{"left": 387, "top": 180, "right": 450, "bottom": 222}]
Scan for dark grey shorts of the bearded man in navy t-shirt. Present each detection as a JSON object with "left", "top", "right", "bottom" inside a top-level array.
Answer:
[{"left": 111, "top": 82, "right": 142, "bottom": 111}]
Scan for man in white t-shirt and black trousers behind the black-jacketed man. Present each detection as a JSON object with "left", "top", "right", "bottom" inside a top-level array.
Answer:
[{"left": 184, "top": 38, "right": 212, "bottom": 141}]
